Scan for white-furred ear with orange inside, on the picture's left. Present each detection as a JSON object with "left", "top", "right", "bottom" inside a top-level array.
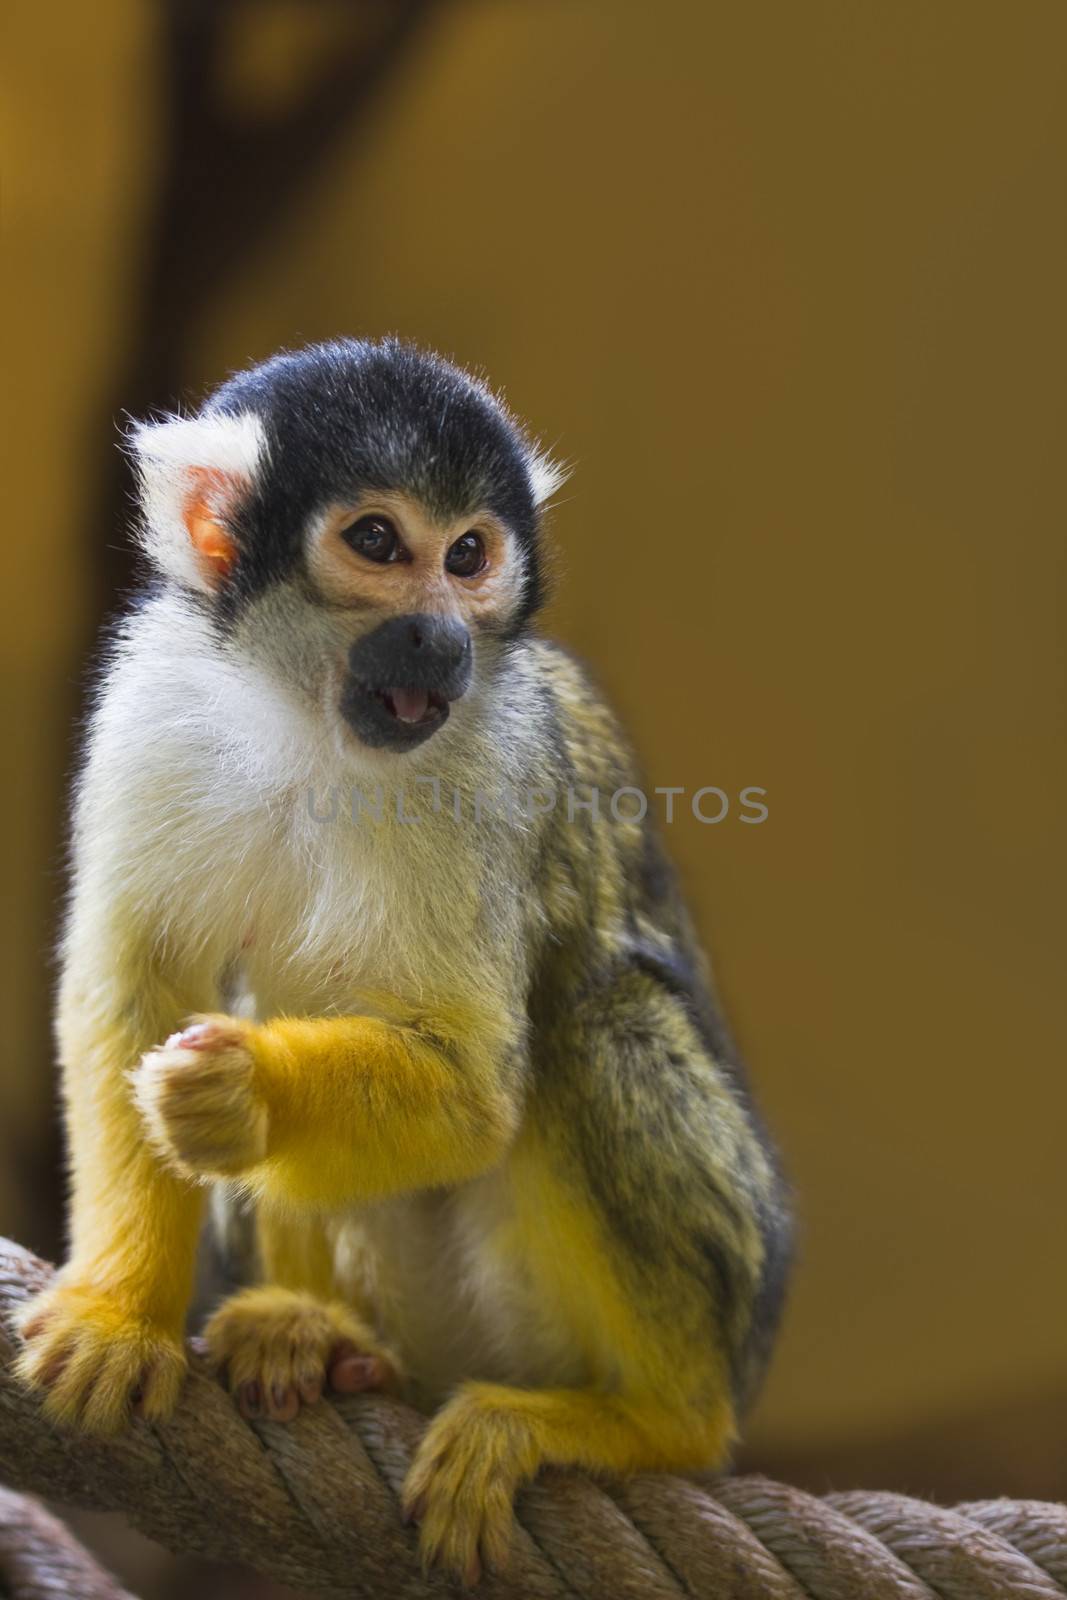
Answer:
[{"left": 128, "top": 413, "right": 266, "bottom": 594}]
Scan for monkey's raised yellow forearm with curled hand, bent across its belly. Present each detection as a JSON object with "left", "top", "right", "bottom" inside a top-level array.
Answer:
[{"left": 136, "top": 997, "right": 518, "bottom": 1210}]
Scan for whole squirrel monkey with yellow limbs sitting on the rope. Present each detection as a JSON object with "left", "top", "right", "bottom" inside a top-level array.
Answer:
[{"left": 21, "top": 341, "right": 790, "bottom": 1581}]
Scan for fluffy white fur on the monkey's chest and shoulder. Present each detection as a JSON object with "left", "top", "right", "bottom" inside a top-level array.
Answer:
[{"left": 80, "top": 597, "right": 537, "bottom": 1014}]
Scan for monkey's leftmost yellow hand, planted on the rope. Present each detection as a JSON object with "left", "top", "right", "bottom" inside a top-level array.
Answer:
[{"left": 14, "top": 1280, "right": 186, "bottom": 1434}]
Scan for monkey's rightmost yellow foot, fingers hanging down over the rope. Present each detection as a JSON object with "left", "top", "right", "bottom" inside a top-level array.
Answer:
[{"left": 403, "top": 1384, "right": 539, "bottom": 1584}]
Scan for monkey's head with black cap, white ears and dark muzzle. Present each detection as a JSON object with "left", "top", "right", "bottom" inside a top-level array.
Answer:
[{"left": 131, "top": 339, "right": 563, "bottom": 752}]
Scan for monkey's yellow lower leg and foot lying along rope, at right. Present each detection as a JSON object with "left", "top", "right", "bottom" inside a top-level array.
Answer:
[{"left": 405, "top": 1384, "right": 734, "bottom": 1582}]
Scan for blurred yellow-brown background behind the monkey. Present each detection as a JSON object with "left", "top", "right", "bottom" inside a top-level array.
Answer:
[{"left": 0, "top": 0, "right": 1067, "bottom": 1594}]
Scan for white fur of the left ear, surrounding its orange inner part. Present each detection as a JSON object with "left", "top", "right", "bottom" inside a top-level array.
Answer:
[{"left": 128, "top": 411, "right": 266, "bottom": 592}]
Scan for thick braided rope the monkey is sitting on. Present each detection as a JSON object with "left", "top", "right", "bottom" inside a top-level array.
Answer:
[{"left": 0, "top": 1242, "right": 1067, "bottom": 1600}]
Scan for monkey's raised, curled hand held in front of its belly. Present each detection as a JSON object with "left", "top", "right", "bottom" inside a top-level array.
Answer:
[{"left": 133, "top": 1016, "right": 267, "bottom": 1178}]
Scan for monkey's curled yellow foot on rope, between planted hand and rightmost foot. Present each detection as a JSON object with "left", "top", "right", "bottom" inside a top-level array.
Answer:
[{"left": 203, "top": 1288, "right": 400, "bottom": 1422}]
